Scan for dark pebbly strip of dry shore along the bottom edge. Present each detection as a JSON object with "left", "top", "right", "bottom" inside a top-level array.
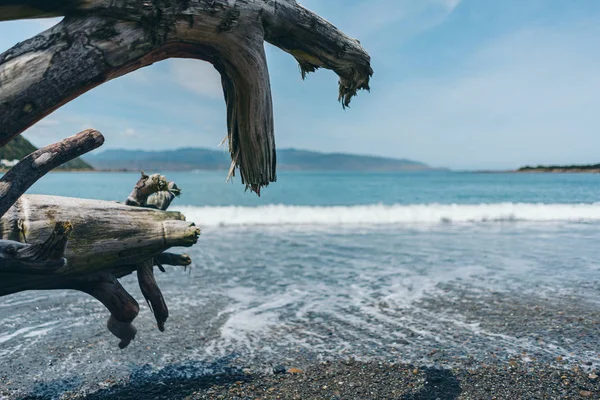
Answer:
[{"left": 24, "top": 360, "right": 600, "bottom": 400}]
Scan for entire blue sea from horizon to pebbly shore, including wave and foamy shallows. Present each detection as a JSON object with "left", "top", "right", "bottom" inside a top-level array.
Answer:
[{"left": 0, "top": 171, "right": 600, "bottom": 397}]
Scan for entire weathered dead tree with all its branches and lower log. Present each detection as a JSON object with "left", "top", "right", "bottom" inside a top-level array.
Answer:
[{"left": 0, "top": 0, "right": 373, "bottom": 347}]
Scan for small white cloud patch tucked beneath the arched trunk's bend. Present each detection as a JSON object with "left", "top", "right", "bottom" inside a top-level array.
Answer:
[{"left": 168, "top": 59, "right": 223, "bottom": 99}]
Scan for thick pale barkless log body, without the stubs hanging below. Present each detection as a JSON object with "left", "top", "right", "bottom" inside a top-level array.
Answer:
[{"left": 0, "top": 195, "right": 200, "bottom": 296}]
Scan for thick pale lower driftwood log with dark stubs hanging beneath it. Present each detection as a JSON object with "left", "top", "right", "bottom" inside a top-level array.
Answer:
[{"left": 0, "top": 190, "right": 200, "bottom": 347}]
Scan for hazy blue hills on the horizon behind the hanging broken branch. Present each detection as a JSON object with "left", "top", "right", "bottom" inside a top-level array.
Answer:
[{"left": 85, "top": 148, "right": 430, "bottom": 171}]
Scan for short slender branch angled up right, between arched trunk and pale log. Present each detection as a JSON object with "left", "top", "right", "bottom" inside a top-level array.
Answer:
[{"left": 0, "top": 129, "right": 104, "bottom": 216}]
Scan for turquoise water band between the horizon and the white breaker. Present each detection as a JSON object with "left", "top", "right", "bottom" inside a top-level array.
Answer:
[{"left": 24, "top": 171, "right": 600, "bottom": 206}]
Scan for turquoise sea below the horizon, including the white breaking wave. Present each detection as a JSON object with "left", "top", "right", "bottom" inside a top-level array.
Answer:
[{"left": 23, "top": 171, "right": 600, "bottom": 228}]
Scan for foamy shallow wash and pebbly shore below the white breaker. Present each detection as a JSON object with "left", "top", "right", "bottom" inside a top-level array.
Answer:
[{"left": 0, "top": 225, "right": 600, "bottom": 400}]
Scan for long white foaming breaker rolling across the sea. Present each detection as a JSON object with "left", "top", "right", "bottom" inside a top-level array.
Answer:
[{"left": 178, "top": 203, "right": 600, "bottom": 227}]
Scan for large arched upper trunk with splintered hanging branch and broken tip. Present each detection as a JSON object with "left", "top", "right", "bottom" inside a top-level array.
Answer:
[{"left": 0, "top": 0, "right": 372, "bottom": 193}]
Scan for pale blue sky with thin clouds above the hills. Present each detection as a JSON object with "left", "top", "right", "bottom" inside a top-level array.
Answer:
[{"left": 0, "top": 0, "right": 600, "bottom": 169}]
